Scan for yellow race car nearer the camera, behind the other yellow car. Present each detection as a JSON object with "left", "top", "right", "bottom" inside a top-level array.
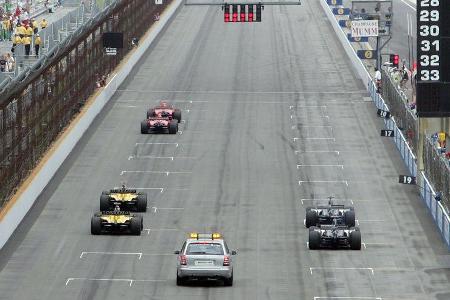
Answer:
[{"left": 91, "top": 207, "right": 144, "bottom": 235}]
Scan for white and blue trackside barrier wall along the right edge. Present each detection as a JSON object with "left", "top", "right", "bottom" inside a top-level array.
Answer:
[{"left": 320, "top": 0, "right": 450, "bottom": 249}]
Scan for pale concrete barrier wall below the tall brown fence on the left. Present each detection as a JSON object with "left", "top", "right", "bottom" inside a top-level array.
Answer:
[{"left": 0, "top": 0, "right": 182, "bottom": 248}]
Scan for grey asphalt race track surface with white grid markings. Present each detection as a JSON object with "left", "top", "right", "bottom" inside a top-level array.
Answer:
[{"left": 0, "top": 0, "right": 450, "bottom": 300}]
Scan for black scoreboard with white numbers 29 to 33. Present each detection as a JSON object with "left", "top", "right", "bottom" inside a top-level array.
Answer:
[{"left": 416, "top": 0, "right": 450, "bottom": 117}]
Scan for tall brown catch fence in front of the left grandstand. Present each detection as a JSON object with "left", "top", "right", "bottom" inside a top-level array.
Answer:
[{"left": 0, "top": 0, "right": 170, "bottom": 205}]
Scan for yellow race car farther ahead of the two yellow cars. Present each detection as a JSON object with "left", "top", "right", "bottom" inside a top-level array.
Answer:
[{"left": 100, "top": 185, "right": 147, "bottom": 212}]
